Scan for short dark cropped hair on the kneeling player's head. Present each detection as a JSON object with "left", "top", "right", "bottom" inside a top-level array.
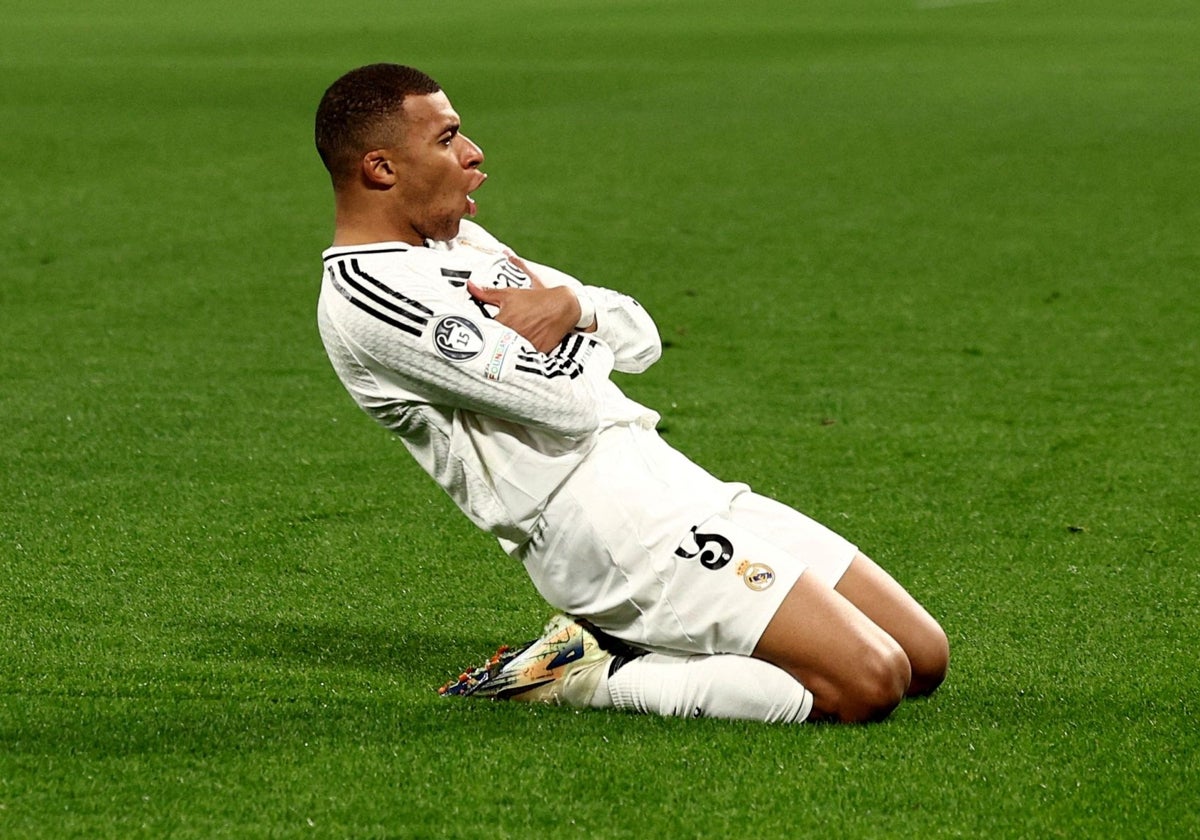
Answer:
[{"left": 316, "top": 64, "right": 442, "bottom": 186}]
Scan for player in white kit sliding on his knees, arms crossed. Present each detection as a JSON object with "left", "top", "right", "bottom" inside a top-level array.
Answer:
[{"left": 316, "top": 65, "right": 949, "bottom": 722}]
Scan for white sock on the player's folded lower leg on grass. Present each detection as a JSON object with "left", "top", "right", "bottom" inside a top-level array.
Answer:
[{"left": 593, "top": 653, "right": 812, "bottom": 724}]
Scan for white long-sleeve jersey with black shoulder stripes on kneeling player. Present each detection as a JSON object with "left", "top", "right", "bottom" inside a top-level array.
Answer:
[{"left": 317, "top": 221, "right": 661, "bottom": 552}]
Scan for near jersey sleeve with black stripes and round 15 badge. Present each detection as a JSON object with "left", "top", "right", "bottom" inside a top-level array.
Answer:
[{"left": 320, "top": 258, "right": 614, "bottom": 439}]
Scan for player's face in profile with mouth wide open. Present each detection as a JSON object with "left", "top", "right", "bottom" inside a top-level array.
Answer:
[{"left": 391, "top": 91, "right": 487, "bottom": 244}]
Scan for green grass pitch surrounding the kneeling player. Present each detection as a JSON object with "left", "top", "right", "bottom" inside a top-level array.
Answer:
[{"left": 0, "top": 0, "right": 1200, "bottom": 839}]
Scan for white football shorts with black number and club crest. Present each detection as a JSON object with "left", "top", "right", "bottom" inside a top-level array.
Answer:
[{"left": 516, "top": 426, "right": 858, "bottom": 655}]
